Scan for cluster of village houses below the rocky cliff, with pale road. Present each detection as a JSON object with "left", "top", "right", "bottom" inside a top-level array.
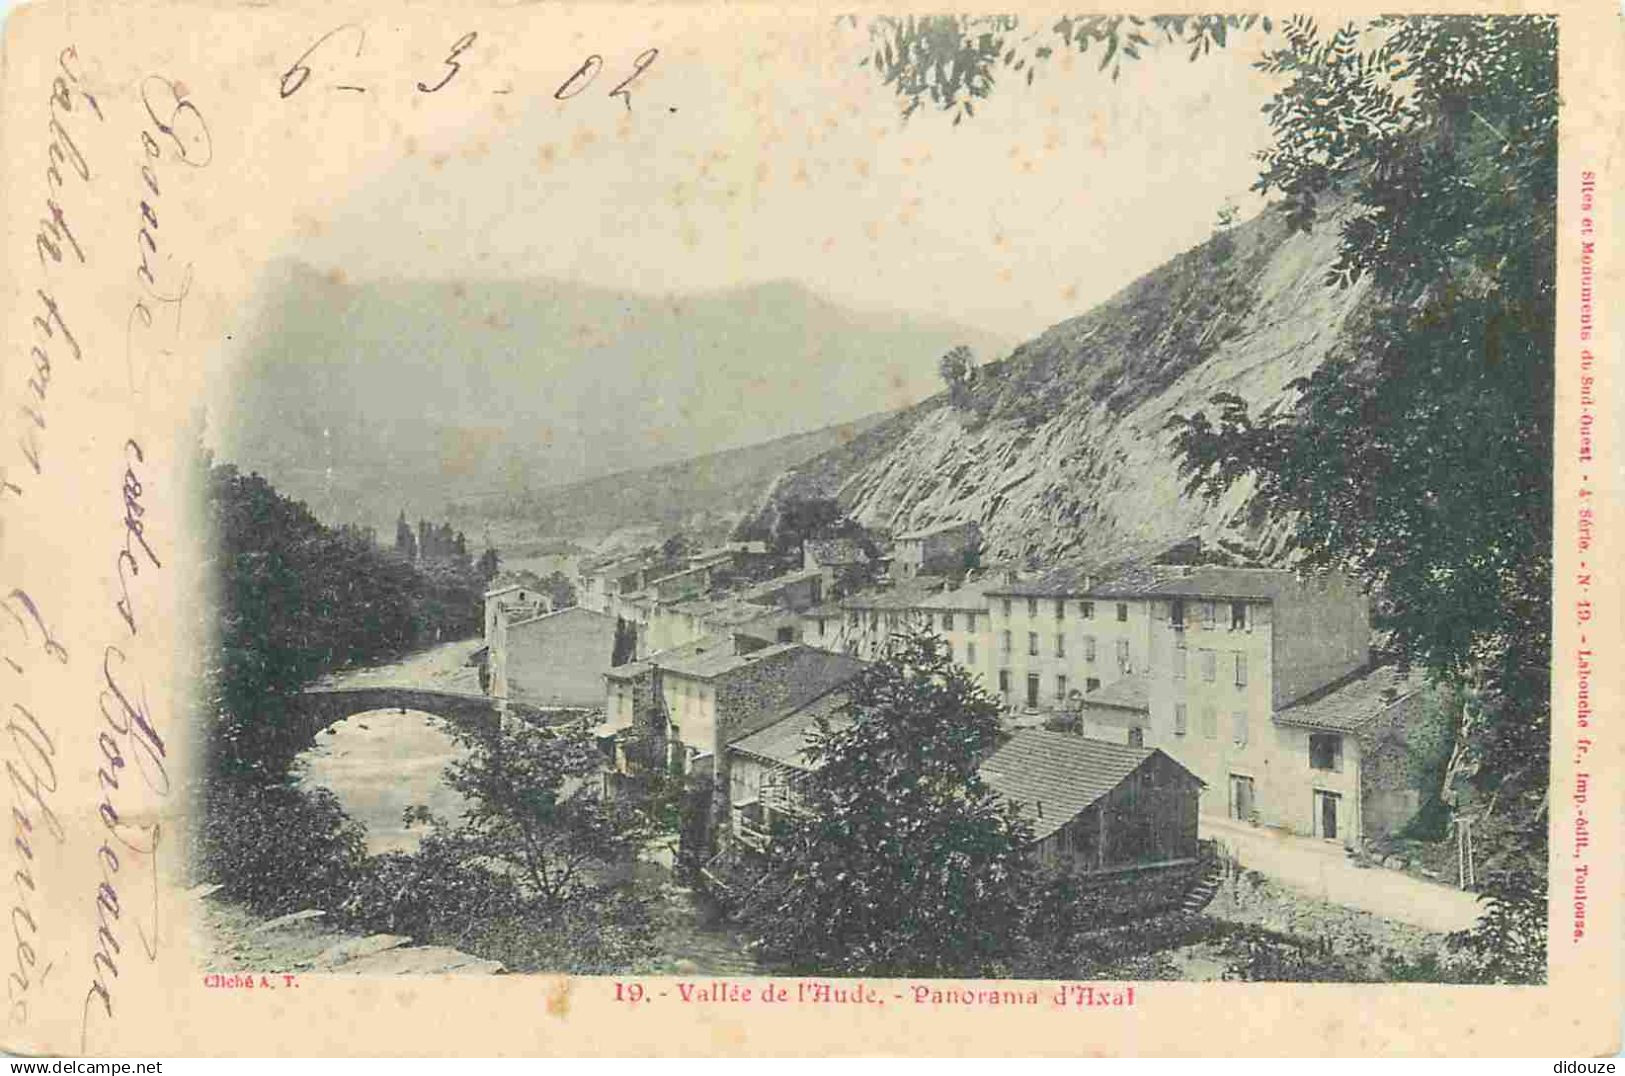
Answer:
[{"left": 470, "top": 520, "right": 1476, "bottom": 931}]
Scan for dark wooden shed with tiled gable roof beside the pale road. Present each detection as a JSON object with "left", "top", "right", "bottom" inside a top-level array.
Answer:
[{"left": 982, "top": 730, "right": 1203, "bottom": 873}]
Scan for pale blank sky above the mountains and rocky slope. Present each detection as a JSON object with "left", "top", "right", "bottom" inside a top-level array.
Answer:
[{"left": 284, "top": 18, "right": 1269, "bottom": 341}]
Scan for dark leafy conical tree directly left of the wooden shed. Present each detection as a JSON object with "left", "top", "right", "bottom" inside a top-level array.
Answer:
[{"left": 744, "top": 634, "right": 1035, "bottom": 975}]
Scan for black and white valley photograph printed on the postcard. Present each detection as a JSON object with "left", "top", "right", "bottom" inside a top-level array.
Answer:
[{"left": 193, "top": 15, "right": 1557, "bottom": 1003}]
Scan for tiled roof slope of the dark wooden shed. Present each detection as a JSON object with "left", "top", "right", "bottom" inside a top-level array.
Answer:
[{"left": 982, "top": 728, "right": 1155, "bottom": 840}]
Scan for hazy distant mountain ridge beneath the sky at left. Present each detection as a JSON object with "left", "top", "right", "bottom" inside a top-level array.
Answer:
[{"left": 211, "top": 260, "right": 1008, "bottom": 528}]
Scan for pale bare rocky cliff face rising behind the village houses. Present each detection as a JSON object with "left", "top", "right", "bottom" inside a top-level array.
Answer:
[{"left": 774, "top": 203, "right": 1363, "bottom": 562}]
